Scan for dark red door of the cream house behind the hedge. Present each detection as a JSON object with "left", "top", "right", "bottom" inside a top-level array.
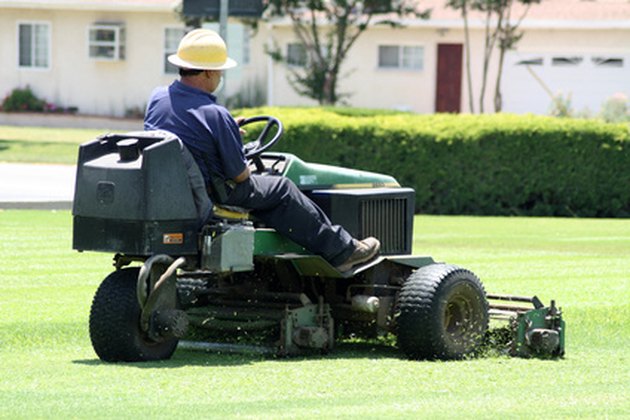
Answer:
[{"left": 435, "top": 44, "right": 463, "bottom": 112}]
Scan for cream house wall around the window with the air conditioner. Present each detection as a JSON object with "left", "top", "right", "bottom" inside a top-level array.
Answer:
[{"left": 0, "top": 8, "right": 266, "bottom": 116}]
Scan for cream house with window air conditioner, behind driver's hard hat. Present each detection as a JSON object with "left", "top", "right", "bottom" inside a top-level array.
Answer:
[{"left": 0, "top": 0, "right": 266, "bottom": 116}]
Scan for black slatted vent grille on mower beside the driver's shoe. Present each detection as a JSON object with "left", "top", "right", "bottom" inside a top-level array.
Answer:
[{"left": 360, "top": 198, "right": 410, "bottom": 254}]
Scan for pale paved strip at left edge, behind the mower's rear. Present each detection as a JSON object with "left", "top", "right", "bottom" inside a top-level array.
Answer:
[{"left": 0, "top": 163, "right": 76, "bottom": 210}]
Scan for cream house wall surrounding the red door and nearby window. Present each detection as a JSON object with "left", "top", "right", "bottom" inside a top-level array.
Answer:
[{"left": 270, "top": 22, "right": 496, "bottom": 113}]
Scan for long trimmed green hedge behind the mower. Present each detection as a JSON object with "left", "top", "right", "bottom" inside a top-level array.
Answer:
[{"left": 240, "top": 108, "right": 630, "bottom": 217}]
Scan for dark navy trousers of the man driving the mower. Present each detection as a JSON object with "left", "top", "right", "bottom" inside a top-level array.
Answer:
[{"left": 224, "top": 175, "right": 354, "bottom": 266}]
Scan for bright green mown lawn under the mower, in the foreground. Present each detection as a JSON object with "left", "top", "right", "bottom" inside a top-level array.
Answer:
[{"left": 0, "top": 211, "right": 630, "bottom": 419}]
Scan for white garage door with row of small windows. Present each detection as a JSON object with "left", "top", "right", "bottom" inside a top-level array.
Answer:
[{"left": 501, "top": 52, "right": 630, "bottom": 115}]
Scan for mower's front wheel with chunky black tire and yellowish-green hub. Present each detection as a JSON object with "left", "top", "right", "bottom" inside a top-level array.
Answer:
[{"left": 397, "top": 264, "right": 488, "bottom": 360}]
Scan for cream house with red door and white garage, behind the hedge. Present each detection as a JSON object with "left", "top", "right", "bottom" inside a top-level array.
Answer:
[{"left": 269, "top": 0, "right": 630, "bottom": 114}]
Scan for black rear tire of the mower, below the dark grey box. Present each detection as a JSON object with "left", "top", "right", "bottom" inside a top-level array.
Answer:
[{"left": 90, "top": 267, "right": 178, "bottom": 362}]
